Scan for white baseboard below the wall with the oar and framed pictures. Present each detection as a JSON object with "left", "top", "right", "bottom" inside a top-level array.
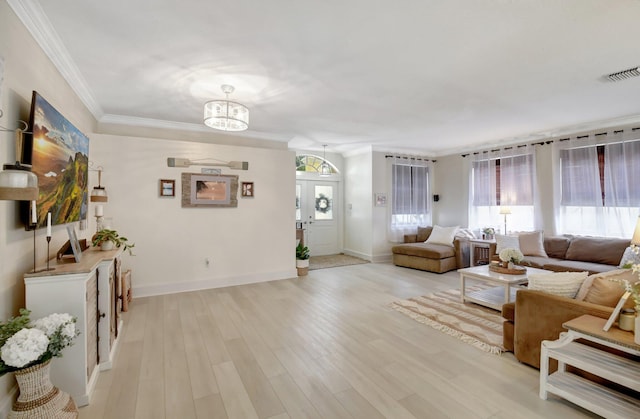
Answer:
[{"left": 132, "top": 268, "right": 298, "bottom": 299}]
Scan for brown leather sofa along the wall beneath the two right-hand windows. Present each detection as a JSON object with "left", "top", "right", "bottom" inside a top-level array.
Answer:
[{"left": 489, "top": 235, "right": 631, "bottom": 274}]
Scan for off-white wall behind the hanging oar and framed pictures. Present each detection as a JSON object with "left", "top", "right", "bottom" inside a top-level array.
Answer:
[{"left": 89, "top": 134, "right": 296, "bottom": 296}]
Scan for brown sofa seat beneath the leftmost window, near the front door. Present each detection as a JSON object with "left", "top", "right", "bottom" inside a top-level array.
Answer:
[{"left": 391, "top": 227, "right": 469, "bottom": 273}]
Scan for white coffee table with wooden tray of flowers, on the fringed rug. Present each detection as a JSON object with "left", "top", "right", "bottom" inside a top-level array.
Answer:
[{"left": 458, "top": 265, "right": 549, "bottom": 310}]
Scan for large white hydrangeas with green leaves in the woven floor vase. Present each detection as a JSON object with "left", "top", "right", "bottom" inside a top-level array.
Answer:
[{"left": 0, "top": 309, "right": 79, "bottom": 375}]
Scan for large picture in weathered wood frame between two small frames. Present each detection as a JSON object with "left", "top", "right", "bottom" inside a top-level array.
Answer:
[{"left": 182, "top": 173, "right": 238, "bottom": 208}]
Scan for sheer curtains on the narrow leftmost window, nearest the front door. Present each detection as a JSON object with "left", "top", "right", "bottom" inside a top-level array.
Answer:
[{"left": 387, "top": 156, "right": 432, "bottom": 242}]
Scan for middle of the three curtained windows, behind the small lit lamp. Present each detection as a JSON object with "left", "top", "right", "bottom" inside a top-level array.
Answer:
[{"left": 469, "top": 145, "right": 541, "bottom": 233}]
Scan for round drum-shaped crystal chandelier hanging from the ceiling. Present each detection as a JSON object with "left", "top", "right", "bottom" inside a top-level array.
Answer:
[{"left": 204, "top": 84, "right": 249, "bottom": 131}]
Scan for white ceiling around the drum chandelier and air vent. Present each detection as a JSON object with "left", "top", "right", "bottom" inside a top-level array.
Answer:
[{"left": 8, "top": 0, "right": 640, "bottom": 156}]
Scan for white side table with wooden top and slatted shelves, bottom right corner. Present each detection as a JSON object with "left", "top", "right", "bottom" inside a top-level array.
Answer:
[{"left": 540, "top": 314, "right": 640, "bottom": 418}]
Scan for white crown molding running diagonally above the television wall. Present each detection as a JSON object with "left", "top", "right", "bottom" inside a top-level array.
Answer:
[{"left": 7, "top": 0, "right": 104, "bottom": 119}]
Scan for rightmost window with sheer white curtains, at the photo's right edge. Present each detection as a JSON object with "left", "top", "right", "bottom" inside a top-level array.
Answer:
[{"left": 554, "top": 130, "right": 640, "bottom": 238}]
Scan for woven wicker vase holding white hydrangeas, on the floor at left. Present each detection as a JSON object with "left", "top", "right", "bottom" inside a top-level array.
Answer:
[{"left": 7, "top": 360, "right": 78, "bottom": 419}]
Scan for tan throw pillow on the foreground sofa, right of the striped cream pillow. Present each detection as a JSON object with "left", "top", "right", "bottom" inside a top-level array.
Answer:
[{"left": 576, "top": 269, "right": 636, "bottom": 307}]
